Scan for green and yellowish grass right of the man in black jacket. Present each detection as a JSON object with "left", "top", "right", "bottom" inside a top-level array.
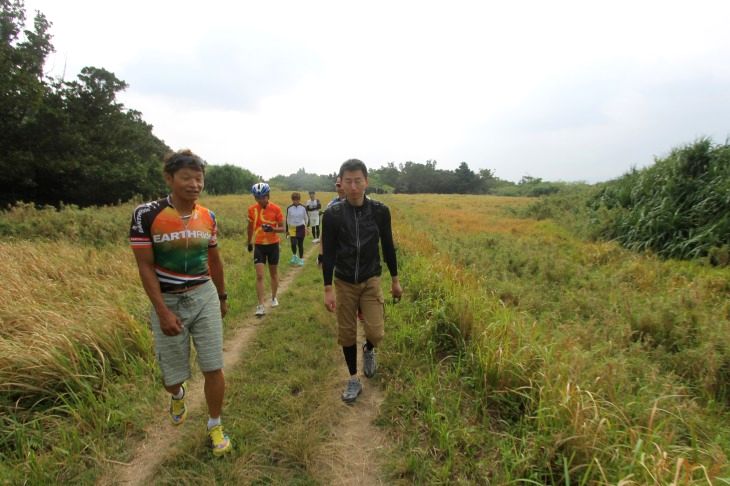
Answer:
[{"left": 376, "top": 196, "right": 730, "bottom": 484}]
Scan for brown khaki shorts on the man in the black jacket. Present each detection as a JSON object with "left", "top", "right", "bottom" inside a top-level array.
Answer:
[{"left": 335, "top": 277, "right": 385, "bottom": 347}]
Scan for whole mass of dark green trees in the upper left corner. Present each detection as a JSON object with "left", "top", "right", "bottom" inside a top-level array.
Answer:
[{"left": 0, "top": 0, "right": 169, "bottom": 206}]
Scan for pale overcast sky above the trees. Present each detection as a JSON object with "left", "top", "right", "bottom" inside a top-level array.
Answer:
[{"left": 19, "top": 0, "right": 730, "bottom": 182}]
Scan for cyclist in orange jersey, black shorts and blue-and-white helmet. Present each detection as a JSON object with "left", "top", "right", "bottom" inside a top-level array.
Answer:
[{"left": 247, "top": 182, "right": 285, "bottom": 317}]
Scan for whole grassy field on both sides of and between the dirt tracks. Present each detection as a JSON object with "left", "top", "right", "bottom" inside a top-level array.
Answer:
[{"left": 0, "top": 193, "right": 730, "bottom": 484}]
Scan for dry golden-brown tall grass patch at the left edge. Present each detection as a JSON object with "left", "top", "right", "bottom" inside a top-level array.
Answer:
[{"left": 0, "top": 241, "right": 148, "bottom": 403}]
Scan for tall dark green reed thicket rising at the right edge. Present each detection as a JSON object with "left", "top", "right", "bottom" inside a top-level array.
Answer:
[{"left": 591, "top": 139, "right": 730, "bottom": 263}]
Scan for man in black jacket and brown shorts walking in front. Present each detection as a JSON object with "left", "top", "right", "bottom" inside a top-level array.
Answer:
[{"left": 322, "top": 159, "right": 403, "bottom": 403}]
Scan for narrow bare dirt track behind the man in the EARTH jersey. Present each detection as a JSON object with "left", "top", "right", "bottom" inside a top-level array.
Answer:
[{"left": 97, "top": 246, "right": 318, "bottom": 485}]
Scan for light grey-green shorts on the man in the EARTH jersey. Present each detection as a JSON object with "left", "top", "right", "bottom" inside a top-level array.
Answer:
[{"left": 150, "top": 280, "right": 223, "bottom": 386}]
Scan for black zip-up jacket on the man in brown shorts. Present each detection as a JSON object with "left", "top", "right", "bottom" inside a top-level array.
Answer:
[{"left": 322, "top": 198, "right": 398, "bottom": 285}]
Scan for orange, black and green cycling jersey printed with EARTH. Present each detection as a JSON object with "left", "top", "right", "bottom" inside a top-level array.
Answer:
[{"left": 129, "top": 196, "right": 218, "bottom": 292}]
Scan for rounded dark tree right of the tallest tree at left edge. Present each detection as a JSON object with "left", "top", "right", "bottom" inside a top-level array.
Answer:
[{"left": 27, "top": 67, "right": 169, "bottom": 206}]
